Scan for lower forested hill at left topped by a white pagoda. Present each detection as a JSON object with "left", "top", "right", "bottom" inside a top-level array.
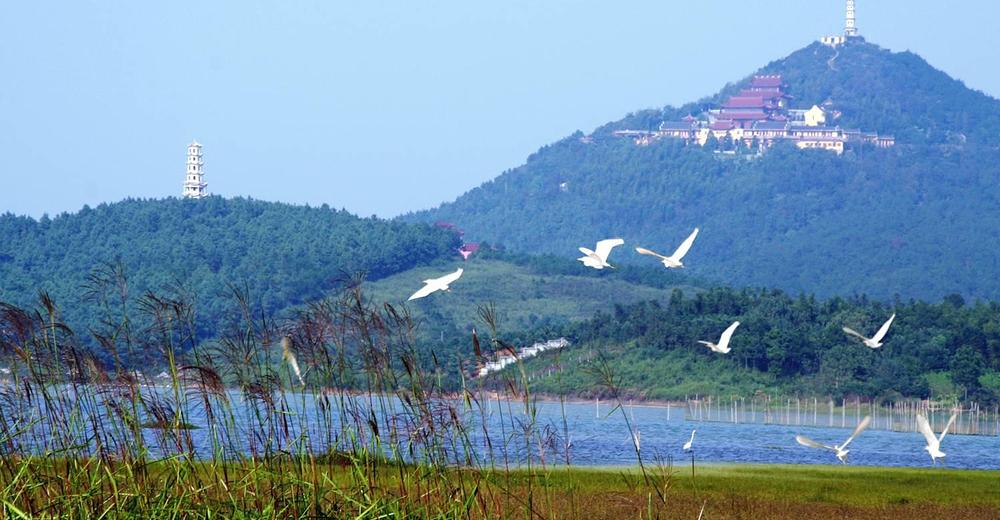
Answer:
[{"left": 0, "top": 197, "right": 460, "bottom": 342}]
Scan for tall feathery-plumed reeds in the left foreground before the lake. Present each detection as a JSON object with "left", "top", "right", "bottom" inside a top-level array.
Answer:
[{"left": 0, "top": 265, "right": 669, "bottom": 518}]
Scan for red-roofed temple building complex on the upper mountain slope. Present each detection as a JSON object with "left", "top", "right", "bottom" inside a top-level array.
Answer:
[{"left": 614, "top": 75, "right": 896, "bottom": 154}]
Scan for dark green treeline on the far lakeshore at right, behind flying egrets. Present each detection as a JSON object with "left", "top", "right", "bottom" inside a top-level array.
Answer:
[{"left": 524, "top": 288, "right": 1000, "bottom": 403}]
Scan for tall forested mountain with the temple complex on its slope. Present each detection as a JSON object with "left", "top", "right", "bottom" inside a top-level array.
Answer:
[{"left": 404, "top": 42, "right": 1000, "bottom": 300}]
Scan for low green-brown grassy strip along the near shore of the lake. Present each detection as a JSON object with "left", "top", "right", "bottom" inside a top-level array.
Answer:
[{"left": 7, "top": 458, "right": 1000, "bottom": 520}]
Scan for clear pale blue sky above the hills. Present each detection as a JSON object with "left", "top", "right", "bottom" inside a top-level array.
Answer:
[{"left": 0, "top": 0, "right": 1000, "bottom": 218}]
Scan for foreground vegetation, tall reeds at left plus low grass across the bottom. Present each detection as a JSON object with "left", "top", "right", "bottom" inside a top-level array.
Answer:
[{"left": 0, "top": 280, "right": 1000, "bottom": 519}]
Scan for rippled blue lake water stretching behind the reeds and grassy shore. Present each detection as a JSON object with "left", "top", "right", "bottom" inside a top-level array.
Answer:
[{"left": 11, "top": 389, "right": 1000, "bottom": 470}]
